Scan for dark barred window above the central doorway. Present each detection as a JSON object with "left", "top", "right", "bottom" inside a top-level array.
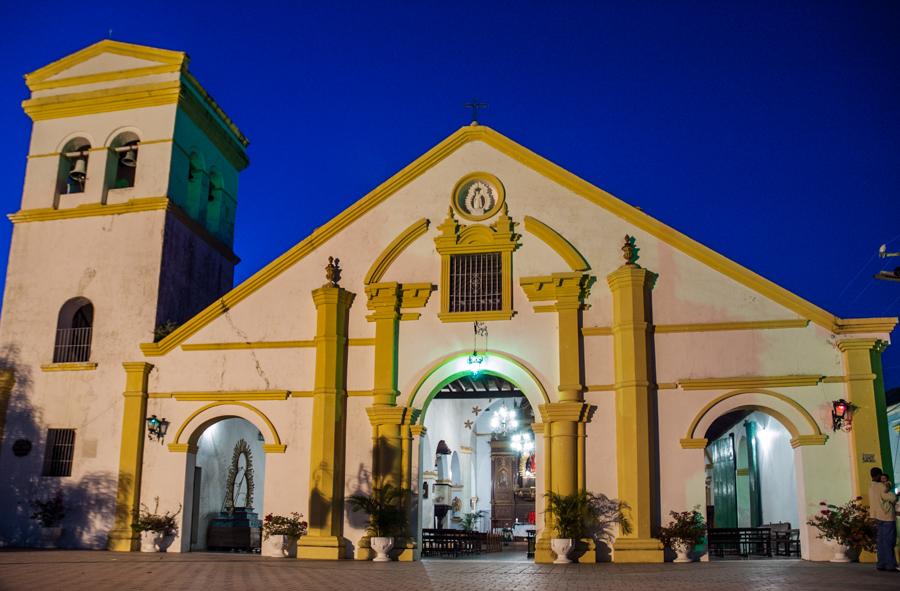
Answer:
[{"left": 449, "top": 252, "right": 503, "bottom": 312}]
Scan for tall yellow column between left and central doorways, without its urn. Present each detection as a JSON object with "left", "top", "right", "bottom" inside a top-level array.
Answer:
[{"left": 297, "top": 280, "right": 355, "bottom": 560}]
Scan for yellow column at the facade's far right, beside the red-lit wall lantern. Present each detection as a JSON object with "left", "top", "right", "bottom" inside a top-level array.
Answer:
[{"left": 837, "top": 339, "right": 882, "bottom": 505}]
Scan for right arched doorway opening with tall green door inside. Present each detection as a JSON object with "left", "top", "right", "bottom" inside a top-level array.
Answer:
[{"left": 705, "top": 409, "right": 800, "bottom": 558}]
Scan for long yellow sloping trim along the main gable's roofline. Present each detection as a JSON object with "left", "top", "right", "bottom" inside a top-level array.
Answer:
[{"left": 141, "top": 125, "right": 894, "bottom": 357}]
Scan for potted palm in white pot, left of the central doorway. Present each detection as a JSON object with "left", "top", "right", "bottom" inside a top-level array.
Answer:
[{"left": 347, "top": 484, "right": 408, "bottom": 562}]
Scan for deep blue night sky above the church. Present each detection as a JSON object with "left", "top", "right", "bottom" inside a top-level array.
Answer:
[{"left": 0, "top": 0, "right": 900, "bottom": 386}]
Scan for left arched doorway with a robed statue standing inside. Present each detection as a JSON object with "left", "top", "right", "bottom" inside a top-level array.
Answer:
[{"left": 183, "top": 417, "right": 266, "bottom": 552}]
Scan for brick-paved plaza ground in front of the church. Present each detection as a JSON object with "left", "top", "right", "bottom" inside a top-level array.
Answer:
[{"left": 0, "top": 551, "right": 900, "bottom": 591}]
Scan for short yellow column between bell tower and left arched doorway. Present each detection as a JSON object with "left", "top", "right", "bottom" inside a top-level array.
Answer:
[{"left": 107, "top": 362, "right": 153, "bottom": 552}]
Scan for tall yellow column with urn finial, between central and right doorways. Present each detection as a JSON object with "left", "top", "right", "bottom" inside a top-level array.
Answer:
[{"left": 607, "top": 256, "right": 663, "bottom": 562}]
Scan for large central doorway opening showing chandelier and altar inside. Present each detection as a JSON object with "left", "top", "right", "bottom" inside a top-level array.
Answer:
[{"left": 420, "top": 372, "right": 537, "bottom": 560}]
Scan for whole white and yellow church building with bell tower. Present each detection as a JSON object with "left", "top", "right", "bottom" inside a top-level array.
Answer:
[{"left": 0, "top": 41, "right": 897, "bottom": 562}]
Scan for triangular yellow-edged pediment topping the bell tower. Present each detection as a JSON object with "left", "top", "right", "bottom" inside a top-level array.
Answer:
[{"left": 25, "top": 39, "right": 187, "bottom": 91}]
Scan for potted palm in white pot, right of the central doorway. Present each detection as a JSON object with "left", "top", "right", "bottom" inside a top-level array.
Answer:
[{"left": 544, "top": 490, "right": 631, "bottom": 564}]
